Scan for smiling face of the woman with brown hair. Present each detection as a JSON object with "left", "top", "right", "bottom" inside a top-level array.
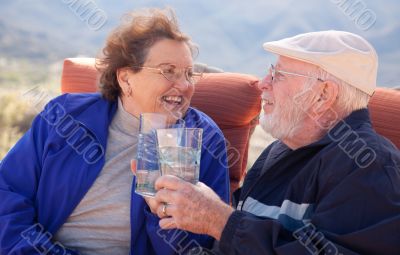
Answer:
[{"left": 119, "top": 39, "right": 194, "bottom": 120}]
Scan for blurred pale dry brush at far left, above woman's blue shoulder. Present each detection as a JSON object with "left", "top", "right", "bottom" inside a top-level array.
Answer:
[{"left": 0, "top": 57, "right": 62, "bottom": 160}]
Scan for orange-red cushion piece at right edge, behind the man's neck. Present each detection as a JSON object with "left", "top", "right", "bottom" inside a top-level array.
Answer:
[{"left": 368, "top": 88, "right": 400, "bottom": 148}]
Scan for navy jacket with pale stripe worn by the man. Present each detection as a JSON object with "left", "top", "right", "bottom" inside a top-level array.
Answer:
[{"left": 219, "top": 109, "right": 400, "bottom": 255}]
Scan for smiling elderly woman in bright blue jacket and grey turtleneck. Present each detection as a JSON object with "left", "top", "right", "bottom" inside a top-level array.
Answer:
[{"left": 0, "top": 7, "right": 229, "bottom": 255}]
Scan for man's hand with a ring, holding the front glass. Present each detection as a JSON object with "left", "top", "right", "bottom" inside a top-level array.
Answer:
[{"left": 155, "top": 175, "right": 234, "bottom": 240}]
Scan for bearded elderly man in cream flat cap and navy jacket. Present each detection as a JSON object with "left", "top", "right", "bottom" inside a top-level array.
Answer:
[{"left": 152, "top": 31, "right": 400, "bottom": 255}]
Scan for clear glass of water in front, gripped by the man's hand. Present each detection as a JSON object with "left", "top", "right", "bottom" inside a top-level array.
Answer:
[{"left": 156, "top": 128, "right": 203, "bottom": 184}]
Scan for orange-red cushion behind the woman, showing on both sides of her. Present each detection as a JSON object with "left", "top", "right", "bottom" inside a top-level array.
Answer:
[{"left": 61, "top": 58, "right": 261, "bottom": 192}]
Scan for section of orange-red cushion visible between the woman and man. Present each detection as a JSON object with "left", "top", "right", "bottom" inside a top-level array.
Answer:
[{"left": 191, "top": 73, "right": 261, "bottom": 191}]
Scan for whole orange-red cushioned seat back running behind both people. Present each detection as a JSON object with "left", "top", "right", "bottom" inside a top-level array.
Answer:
[{"left": 61, "top": 58, "right": 400, "bottom": 192}]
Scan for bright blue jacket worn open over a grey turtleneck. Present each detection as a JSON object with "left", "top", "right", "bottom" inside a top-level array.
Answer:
[{"left": 0, "top": 94, "right": 229, "bottom": 255}]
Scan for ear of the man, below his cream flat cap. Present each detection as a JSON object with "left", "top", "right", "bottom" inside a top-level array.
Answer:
[{"left": 313, "top": 81, "right": 338, "bottom": 115}]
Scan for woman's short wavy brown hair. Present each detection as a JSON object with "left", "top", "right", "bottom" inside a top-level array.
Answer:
[{"left": 96, "top": 8, "right": 197, "bottom": 101}]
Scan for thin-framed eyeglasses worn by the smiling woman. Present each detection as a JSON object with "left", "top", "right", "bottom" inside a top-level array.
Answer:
[{"left": 133, "top": 66, "right": 203, "bottom": 85}]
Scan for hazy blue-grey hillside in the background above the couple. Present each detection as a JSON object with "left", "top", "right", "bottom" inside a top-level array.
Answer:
[{"left": 0, "top": 0, "right": 400, "bottom": 86}]
